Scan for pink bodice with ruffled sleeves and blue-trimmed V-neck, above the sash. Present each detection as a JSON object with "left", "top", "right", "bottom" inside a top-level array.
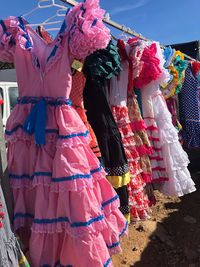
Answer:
[{"left": 0, "top": 0, "right": 110, "bottom": 98}]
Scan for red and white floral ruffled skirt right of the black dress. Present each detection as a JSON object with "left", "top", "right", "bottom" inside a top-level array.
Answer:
[{"left": 111, "top": 106, "right": 149, "bottom": 221}]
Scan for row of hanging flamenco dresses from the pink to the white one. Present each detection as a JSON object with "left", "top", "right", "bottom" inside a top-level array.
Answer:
[{"left": 0, "top": 0, "right": 198, "bottom": 267}]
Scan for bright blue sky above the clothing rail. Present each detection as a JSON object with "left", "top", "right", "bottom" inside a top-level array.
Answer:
[{"left": 0, "top": 0, "right": 200, "bottom": 44}]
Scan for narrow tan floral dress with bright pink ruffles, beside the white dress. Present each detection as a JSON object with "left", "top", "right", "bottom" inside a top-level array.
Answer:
[{"left": 118, "top": 38, "right": 156, "bottom": 205}]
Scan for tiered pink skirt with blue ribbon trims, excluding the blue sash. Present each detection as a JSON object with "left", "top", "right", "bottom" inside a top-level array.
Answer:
[{"left": 6, "top": 104, "right": 127, "bottom": 267}]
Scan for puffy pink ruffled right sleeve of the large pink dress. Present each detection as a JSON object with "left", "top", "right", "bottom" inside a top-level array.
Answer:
[{"left": 66, "top": 0, "right": 111, "bottom": 60}]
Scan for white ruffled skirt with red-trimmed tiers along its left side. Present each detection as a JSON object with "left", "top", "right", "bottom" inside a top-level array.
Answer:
[{"left": 143, "top": 89, "right": 196, "bottom": 196}]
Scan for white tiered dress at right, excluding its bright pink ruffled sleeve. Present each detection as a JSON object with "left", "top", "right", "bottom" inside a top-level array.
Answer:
[{"left": 141, "top": 43, "right": 196, "bottom": 196}]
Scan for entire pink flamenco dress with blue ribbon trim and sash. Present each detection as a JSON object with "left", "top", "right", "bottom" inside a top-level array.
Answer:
[{"left": 0, "top": 0, "right": 127, "bottom": 267}]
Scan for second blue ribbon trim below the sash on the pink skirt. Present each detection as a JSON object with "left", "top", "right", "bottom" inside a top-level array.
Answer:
[{"left": 9, "top": 166, "right": 102, "bottom": 182}]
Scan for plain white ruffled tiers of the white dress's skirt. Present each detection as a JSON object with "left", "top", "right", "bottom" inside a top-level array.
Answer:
[{"left": 152, "top": 93, "right": 196, "bottom": 196}]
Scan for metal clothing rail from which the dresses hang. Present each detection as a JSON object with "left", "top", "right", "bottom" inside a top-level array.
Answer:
[{"left": 60, "top": 0, "right": 196, "bottom": 61}]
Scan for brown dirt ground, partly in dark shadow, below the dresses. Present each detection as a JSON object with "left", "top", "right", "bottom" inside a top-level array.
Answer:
[{"left": 113, "top": 172, "right": 200, "bottom": 267}]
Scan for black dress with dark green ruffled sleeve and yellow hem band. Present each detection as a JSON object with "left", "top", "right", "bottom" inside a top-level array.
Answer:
[{"left": 83, "top": 42, "right": 130, "bottom": 219}]
